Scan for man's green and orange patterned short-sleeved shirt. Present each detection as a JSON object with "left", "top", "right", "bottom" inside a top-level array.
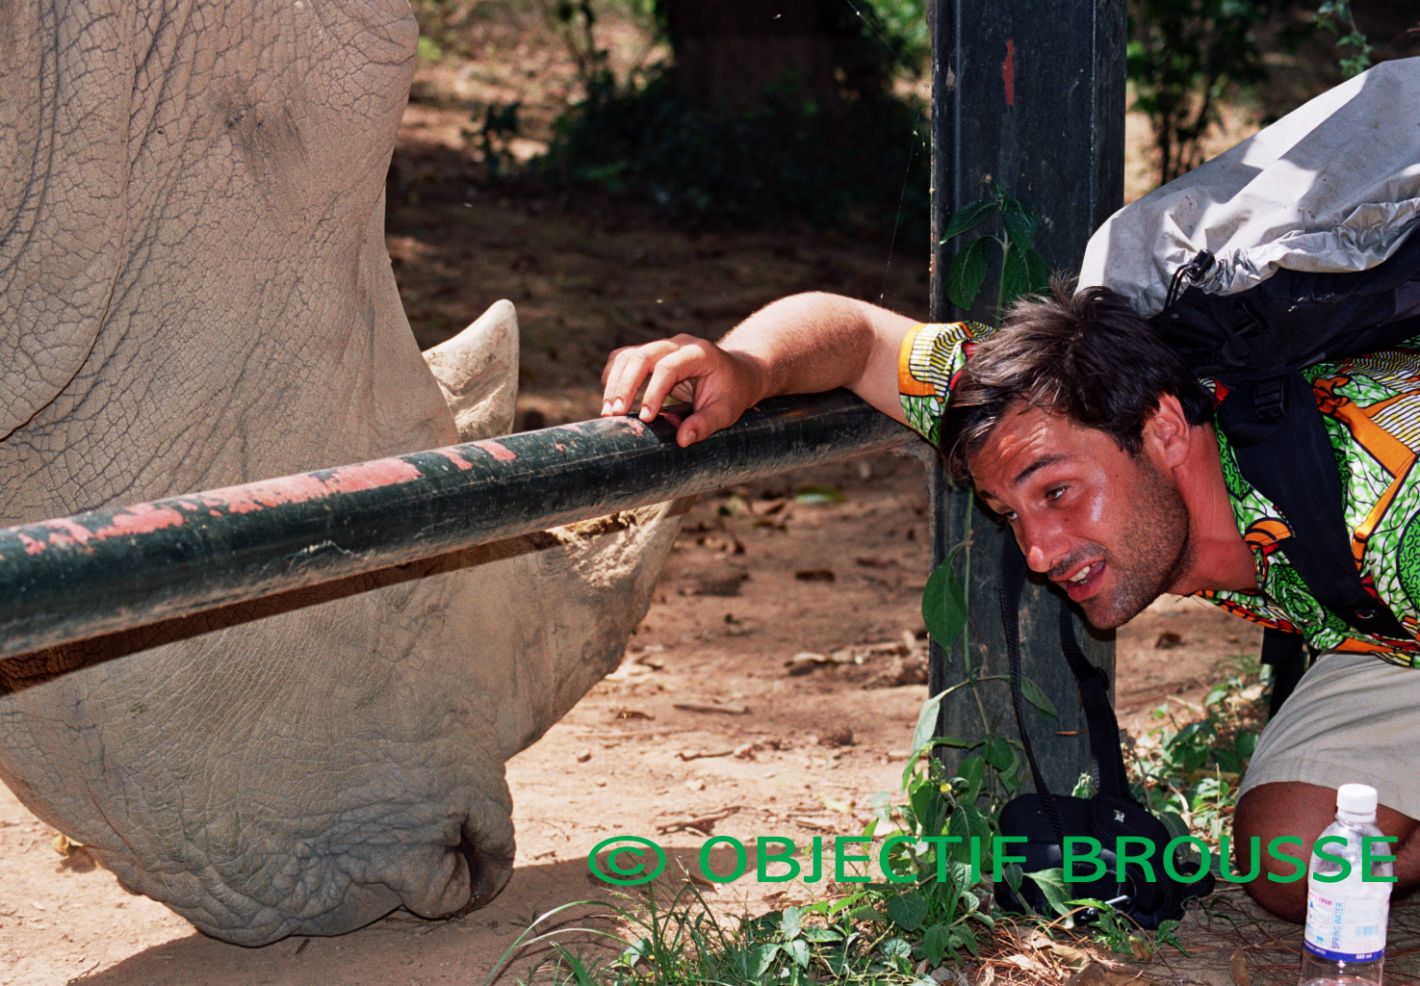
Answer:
[{"left": 897, "top": 323, "right": 1420, "bottom": 668}]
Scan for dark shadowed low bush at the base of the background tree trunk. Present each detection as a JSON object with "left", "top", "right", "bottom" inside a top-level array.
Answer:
[{"left": 540, "top": 65, "right": 929, "bottom": 236}]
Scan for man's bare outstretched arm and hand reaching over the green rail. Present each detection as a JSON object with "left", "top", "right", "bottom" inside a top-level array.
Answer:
[{"left": 602, "top": 291, "right": 919, "bottom": 446}]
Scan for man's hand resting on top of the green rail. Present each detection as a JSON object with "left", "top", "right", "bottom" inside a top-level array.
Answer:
[{"left": 602, "top": 334, "right": 764, "bottom": 448}]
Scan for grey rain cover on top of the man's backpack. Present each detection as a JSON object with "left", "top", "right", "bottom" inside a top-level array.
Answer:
[{"left": 1079, "top": 58, "right": 1420, "bottom": 315}]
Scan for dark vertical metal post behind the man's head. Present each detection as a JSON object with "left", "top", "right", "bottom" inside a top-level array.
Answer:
[{"left": 929, "top": 0, "right": 1125, "bottom": 791}]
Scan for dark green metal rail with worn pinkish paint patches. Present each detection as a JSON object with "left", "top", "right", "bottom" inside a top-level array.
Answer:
[{"left": 0, "top": 391, "right": 916, "bottom": 658}]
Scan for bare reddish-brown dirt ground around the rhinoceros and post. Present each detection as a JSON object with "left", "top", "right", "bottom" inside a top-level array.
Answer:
[{"left": 0, "top": 25, "right": 1391, "bottom": 986}]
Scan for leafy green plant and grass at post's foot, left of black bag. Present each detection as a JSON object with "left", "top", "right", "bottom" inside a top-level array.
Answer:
[{"left": 487, "top": 679, "right": 1020, "bottom": 986}]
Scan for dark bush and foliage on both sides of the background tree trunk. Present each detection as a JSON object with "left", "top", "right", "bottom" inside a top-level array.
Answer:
[{"left": 537, "top": 0, "right": 930, "bottom": 234}]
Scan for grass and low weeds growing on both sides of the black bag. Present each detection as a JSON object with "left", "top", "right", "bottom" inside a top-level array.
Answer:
[{"left": 486, "top": 662, "right": 1265, "bottom": 986}]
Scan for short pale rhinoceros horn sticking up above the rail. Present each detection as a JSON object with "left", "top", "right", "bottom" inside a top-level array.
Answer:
[{"left": 425, "top": 301, "right": 518, "bottom": 442}]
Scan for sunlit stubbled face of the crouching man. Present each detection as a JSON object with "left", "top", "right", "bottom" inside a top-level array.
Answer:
[{"left": 968, "top": 405, "right": 1190, "bottom": 629}]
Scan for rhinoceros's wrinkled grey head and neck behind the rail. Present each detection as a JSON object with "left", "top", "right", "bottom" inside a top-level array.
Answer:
[{"left": 0, "top": 0, "right": 687, "bottom": 945}]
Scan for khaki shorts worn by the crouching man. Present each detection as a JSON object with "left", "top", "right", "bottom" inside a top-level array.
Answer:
[{"left": 1241, "top": 651, "right": 1420, "bottom": 818}]
